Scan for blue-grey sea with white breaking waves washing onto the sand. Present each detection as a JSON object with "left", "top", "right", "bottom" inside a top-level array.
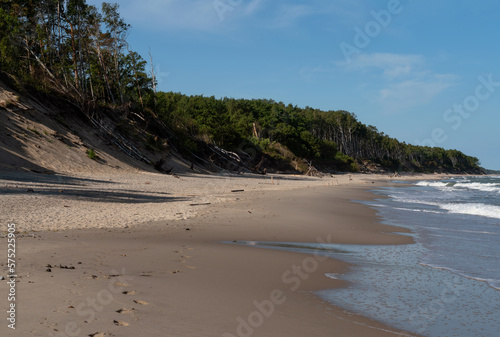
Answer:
[{"left": 234, "top": 176, "right": 500, "bottom": 337}]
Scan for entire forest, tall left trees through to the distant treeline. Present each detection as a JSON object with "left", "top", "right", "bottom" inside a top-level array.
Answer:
[{"left": 0, "top": 0, "right": 483, "bottom": 173}]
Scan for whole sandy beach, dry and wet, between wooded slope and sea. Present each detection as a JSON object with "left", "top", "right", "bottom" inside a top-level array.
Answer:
[{"left": 0, "top": 172, "right": 434, "bottom": 337}]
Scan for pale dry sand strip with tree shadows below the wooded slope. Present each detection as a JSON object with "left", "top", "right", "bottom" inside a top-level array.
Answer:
[{"left": 0, "top": 171, "right": 438, "bottom": 232}]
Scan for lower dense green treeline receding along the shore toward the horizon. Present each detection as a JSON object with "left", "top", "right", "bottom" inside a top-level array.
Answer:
[{"left": 143, "top": 92, "right": 481, "bottom": 173}]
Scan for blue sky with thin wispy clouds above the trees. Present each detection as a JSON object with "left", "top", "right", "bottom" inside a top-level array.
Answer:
[{"left": 87, "top": 0, "right": 500, "bottom": 170}]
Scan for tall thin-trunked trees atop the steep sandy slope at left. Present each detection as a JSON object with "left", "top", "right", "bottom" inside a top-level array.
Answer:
[{"left": 0, "top": 0, "right": 153, "bottom": 105}]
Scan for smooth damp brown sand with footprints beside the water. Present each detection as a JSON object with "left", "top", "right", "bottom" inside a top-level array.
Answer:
[{"left": 0, "top": 172, "right": 434, "bottom": 337}]
